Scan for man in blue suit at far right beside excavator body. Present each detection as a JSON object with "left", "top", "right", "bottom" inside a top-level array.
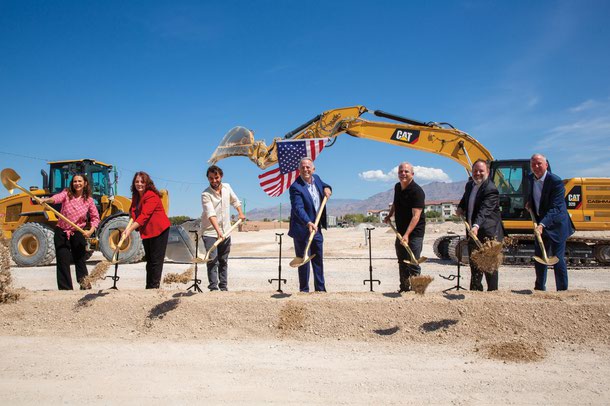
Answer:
[{"left": 527, "top": 154, "right": 574, "bottom": 290}]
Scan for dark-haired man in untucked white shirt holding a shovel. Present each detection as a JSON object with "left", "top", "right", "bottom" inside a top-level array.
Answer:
[{"left": 201, "top": 165, "right": 246, "bottom": 291}]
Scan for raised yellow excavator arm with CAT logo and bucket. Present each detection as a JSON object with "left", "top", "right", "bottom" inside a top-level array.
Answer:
[{"left": 209, "top": 106, "right": 493, "bottom": 172}]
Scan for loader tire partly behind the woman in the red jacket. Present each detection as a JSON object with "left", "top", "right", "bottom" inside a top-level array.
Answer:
[{"left": 99, "top": 216, "right": 144, "bottom": 263}]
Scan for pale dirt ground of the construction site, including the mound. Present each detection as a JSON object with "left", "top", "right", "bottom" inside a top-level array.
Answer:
[{"left": 0, "top": 223, "right": 610, "bottom": 405}]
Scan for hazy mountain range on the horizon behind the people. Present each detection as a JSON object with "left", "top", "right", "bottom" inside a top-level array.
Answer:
[{"left": 247, "top": 180, "right": 466, "bottom": 220}]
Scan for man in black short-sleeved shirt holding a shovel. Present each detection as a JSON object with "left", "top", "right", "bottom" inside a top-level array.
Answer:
[{"left": 384, "top": 162, "right": 426, "bottom": 292}]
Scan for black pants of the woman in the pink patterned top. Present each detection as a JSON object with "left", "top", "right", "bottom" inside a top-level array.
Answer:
[{"left": 53, "top": 227, "right": 88, "bottom": 290}]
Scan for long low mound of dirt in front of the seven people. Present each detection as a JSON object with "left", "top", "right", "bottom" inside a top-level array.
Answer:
[{"left": 0, "top": 290, "right": 610, "bottom": 360}]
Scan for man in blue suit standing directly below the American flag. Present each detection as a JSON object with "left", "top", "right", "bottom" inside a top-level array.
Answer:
[{"left": 288, "top": 158, "right": 332, "bottom": 292}]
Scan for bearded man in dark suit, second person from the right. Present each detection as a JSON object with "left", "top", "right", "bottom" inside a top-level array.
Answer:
[{"left": 457, "top": 159, "right": 504, "bottom": 291}]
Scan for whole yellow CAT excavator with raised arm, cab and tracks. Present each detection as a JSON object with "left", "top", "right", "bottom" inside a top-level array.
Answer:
[{"left": 209, "top": 106, "right": 610, "bottom": 266}]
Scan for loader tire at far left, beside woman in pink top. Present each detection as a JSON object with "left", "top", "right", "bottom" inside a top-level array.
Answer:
[{"left": 10, "top": 223, "right": 55, "bottom": 266}]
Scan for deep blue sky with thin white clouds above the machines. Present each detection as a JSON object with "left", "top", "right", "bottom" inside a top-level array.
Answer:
[{"left": 0, "top": 0, "right": 610, "bottom": 217}]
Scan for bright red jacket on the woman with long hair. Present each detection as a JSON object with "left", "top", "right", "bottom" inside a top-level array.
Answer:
[{"left": 129, "top": 190, "right": 171, "bottom": 240}]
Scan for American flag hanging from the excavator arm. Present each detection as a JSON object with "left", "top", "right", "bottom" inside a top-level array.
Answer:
[{"left": 258, "top": 138, "right": 330, "bottom": 197}]
